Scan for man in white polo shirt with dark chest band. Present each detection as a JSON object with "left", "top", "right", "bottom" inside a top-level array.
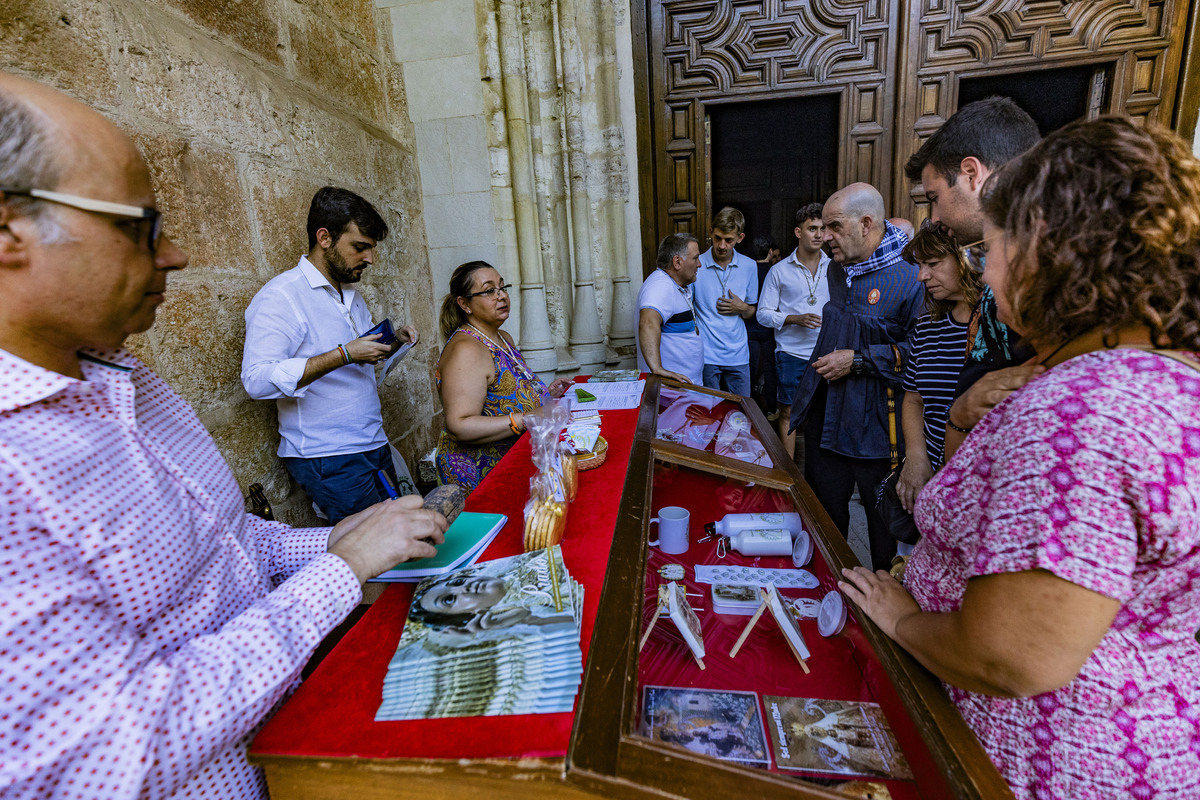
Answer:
[{"left": 636, "top": 234, "right": 704, "bottom": 384}]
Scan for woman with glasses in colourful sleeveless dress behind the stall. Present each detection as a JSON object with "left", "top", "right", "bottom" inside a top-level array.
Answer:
[{"left": 434, "top": 261, "right": 571, "bottom": 492}]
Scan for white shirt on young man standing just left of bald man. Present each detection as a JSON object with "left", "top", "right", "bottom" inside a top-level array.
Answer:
[{"left": 756, "top": 251, "right": 829, "bottom": 360}]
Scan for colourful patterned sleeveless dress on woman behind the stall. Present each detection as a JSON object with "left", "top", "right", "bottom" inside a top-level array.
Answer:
[{"left": 434, "top": 326, "right": 546, "bottom": 493}]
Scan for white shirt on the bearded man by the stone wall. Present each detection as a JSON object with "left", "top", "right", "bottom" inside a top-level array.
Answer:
[{"left": 241, "top": 255, "right": 388, "bottom": 458}]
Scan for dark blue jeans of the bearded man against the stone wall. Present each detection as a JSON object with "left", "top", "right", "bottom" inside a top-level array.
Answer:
[{"left": 283, "top": 445, "right": 396, "bottom": 525}]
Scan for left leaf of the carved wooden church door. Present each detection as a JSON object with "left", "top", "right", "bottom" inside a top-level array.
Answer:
[{"left": 642, "top": 0, "right": 899, "bottom": 247}]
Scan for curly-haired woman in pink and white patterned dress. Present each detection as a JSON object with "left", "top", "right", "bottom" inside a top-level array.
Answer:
[{"left": 841, "top": 118, "right": 1200, "bottom": 800}]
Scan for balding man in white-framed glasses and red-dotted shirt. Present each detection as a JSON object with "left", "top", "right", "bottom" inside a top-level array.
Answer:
[{"left": 0, "top": 73, "right": 445, "bottom": 800}]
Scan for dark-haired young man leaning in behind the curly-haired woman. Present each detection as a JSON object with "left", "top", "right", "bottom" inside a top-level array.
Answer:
[{"left": 905, "top": 96, "right": 1040, "bottom": 459}]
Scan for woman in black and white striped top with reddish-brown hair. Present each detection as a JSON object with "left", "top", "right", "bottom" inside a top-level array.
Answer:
[{"left": 896, "top": 219, "right": 983, "bottom": 512}]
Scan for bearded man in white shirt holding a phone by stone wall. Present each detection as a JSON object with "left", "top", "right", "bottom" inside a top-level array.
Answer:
[{"left": 241, "top": 186, "right": 418, "bottom": 524}]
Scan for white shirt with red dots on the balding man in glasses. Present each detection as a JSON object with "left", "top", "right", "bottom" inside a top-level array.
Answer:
[{"left": 0, "top": 350, "right": 361, "bottom": 800}]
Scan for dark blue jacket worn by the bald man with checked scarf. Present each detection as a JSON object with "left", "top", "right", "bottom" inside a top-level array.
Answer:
[{"left": 792, "top": 253, "right": 925, "bottom": 458}]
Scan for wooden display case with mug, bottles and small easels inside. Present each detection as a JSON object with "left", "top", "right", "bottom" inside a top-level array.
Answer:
[{"left": 566, "top": 378, "right": 1012, "bottom": 800}]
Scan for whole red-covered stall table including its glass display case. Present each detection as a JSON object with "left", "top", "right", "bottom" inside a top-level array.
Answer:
[{"left": 248, "top": 377, "right": 1012, "bottom": 800}]
